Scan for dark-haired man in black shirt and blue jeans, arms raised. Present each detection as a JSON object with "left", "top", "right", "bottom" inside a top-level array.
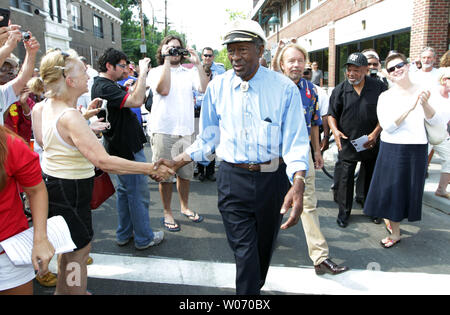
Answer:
[{"left": 91, "top": 48, "right": 164, "bottom": 250}]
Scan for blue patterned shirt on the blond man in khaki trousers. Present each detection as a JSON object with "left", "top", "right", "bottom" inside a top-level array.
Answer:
[{"left": 297, "top": 78, "right": 322, "bottom": 134}]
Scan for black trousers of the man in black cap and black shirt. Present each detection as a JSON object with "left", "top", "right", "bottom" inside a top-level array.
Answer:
[{"left": 337, "top": 159, "right": 376, "bottom": 221}]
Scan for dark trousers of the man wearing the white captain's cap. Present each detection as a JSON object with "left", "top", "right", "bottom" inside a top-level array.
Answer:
[{"left": 217, "top": 162, "right": 289, "bottom": 295}]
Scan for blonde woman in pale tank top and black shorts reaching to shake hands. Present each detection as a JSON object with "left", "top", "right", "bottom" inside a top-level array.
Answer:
[{"left": 30, "top": 50, "right": 173, "bottom": 294}]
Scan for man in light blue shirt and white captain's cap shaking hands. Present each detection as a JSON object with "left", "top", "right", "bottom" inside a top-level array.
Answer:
[{"left": 157, "top": 20, "right": 309, "bottom": 295}]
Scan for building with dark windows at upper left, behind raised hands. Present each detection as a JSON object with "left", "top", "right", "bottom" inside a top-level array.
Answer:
[{"left": 0, "top": 0, "right": 122, "bottom": 68}]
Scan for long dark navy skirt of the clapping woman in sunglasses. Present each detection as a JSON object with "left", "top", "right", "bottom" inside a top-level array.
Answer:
[{"left": 364, "top": 142, "right": 428, "bottom": 222}]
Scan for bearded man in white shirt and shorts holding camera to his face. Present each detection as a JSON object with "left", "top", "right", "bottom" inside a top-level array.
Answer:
[{"left": 147, "top": 36, "right": 208, "bottom": 232}]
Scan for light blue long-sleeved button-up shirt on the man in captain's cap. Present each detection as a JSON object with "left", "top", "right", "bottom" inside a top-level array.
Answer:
[{"left": 186, "top": 67, "right": 309, "bottom": 181}]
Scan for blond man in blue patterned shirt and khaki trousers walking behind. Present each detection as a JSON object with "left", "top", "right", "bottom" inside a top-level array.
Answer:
[{"left": 275, "top": 44, "right": 348, "bottom": 275}]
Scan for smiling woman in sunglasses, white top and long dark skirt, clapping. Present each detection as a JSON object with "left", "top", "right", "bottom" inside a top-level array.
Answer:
[{"left": 364, "top": 53, "right": 440, "bottom": 248}]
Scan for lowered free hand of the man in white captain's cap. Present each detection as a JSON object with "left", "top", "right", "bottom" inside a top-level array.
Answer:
[{"left": 280, "top": 175, "right": 305, "bottom": 230}]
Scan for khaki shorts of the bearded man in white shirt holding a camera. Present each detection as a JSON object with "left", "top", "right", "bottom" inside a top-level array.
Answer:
[{"left": 150, "top": 133, "right": 194, "bottom": 183}]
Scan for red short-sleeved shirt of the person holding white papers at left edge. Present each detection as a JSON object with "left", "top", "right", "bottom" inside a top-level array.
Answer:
[{"left": 0, "top": 135, "right": 42, "bottom": 241}]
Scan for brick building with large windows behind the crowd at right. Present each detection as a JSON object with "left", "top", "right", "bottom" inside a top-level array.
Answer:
[{"left": 252, "top": 0, "right": 450, "bottom": 87}]
